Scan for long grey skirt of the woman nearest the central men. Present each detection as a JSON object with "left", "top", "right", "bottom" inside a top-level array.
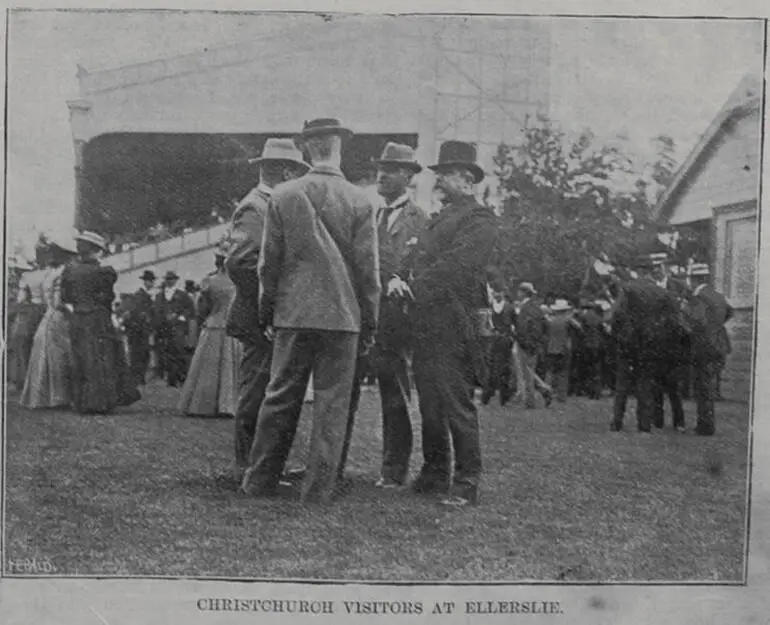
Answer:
[{"left": 178, "top": 328, "right": 243, "bottom": 417}]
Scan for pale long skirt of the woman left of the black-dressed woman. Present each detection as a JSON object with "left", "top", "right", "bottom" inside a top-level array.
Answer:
[{"left": 21, "top": 308, "right": 72, "bottom": 408}]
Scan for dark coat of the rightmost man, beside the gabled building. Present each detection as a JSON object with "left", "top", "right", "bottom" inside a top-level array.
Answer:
[{"left": 685, "top": 286, "right": 733, "bottom": 363}]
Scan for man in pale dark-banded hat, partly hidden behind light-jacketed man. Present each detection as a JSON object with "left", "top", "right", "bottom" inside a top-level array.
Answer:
[{"left": 225, "top": 139, "right": 310, "bottom": 485}]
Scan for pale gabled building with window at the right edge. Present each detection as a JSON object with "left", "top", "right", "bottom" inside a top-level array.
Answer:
[{"left": 655, "top": 74, "right": 763, "bottom": 401}]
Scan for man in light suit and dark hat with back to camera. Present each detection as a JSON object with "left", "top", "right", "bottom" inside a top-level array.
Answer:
[{"left": 242, "top": 119, "right": 381, "bottom": 503}]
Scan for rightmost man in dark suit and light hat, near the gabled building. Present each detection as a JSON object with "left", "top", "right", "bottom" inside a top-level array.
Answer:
[{"left": 685, "top": 264, "right": 733, "bottom": 436}]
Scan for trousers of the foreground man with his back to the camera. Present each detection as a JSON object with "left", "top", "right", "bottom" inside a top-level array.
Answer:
[{"left": 244, "top": 328, "right": 358, "bottom": 503}]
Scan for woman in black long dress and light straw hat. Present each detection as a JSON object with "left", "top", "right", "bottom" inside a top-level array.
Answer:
[{"left": 61, "top": 232, "right": 141, "bottom": 414}]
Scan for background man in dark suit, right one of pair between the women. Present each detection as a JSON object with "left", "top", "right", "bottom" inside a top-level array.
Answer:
[{"left": 155, "top": 271, "right": 195, "bottom": 387}]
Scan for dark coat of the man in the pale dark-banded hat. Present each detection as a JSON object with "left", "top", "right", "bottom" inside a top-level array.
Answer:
[{"left": 225, "top": 188, "right": 270, "bottom": 343}]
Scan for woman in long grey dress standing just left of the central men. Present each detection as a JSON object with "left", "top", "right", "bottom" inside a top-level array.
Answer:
[{"left": 179, "top": 250, "right": 241, "bottom": 417}]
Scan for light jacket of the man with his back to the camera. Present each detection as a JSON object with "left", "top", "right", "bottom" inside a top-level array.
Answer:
[{"left": 259, "top": 166, "right": 381, "bottom": 333}]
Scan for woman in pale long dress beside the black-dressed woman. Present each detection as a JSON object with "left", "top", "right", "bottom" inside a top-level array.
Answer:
[{"left": 20, "top": 242, "right": 76, "bottom": 408}]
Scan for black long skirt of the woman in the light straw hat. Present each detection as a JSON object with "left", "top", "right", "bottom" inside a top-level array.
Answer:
[{"left": 70, "top": 310, "right": 141, "bottom": 414}]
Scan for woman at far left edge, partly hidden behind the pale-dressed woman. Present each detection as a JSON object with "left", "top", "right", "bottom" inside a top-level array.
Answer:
[{"left": 8, "top": 253, "right": 49, "bottom": 391}]
